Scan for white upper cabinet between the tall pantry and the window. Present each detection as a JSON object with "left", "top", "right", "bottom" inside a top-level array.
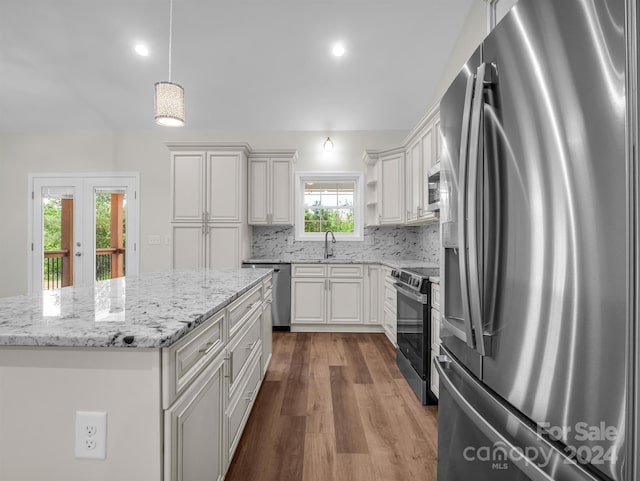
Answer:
[{"left": 249, "top": 150, "right": 298, "bottom": 225}]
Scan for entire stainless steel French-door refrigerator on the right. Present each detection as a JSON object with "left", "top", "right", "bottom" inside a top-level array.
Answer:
[{"left": 437, "top": 0, "right": 638, "bottom": 481}]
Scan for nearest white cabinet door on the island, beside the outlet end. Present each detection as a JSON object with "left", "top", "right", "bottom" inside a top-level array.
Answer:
[{"left": 164, "top": 354, "right": 226, "bottom": 481}]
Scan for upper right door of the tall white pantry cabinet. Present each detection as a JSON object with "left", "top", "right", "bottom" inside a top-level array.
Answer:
[{"left": 206, "top": 152, "right": 246, "bottom": 222}]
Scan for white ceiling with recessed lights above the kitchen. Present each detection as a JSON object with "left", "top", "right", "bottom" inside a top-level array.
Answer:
[{"left": 0, "top": 0, "right": 473, "bottom": 131}]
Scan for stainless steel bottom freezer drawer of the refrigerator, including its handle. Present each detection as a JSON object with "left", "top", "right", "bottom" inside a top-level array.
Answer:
[{"left": 436, "top": 351, "right": 601, "bottom": 481}]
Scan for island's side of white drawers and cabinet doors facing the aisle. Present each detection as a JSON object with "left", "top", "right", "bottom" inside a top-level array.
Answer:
[{"left": 162, "top": 279, "right": 272, "bottom": 481}]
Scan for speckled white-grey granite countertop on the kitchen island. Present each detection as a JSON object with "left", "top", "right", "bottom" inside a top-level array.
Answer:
[{"left": 0, "top": 269, "right": 272, "bottom": 348}]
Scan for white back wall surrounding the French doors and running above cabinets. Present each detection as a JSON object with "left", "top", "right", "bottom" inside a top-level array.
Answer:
[{"left": 0, "top": 128, "right": 407, "bottom": 297}]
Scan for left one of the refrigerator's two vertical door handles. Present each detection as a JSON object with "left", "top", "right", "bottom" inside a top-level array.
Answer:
[{"left": 458, "top": 75, "right": 475, "bottom": 349}]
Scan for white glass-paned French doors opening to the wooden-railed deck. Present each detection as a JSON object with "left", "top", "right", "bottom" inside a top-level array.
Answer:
[{"left": 29, "top": 174, "right": 139, "bottom": 293}]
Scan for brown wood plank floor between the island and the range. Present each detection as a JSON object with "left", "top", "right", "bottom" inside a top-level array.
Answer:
[{"left": 226, "top": 332, "right": 438, "bottom": 481}]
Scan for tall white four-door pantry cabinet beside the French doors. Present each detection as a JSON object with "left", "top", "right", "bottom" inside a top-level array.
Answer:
[{"left": 168, "top": 142, "right": 251, "bottom": 269}]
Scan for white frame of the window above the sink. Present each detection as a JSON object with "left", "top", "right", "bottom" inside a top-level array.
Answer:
[{"left": 294, "top": 172, "right": 364, "bottom": 242}]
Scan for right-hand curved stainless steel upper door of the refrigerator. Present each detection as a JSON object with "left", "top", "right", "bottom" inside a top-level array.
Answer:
[{"left": 482, "top": 0, "right": 630, "bottom": 480}]
